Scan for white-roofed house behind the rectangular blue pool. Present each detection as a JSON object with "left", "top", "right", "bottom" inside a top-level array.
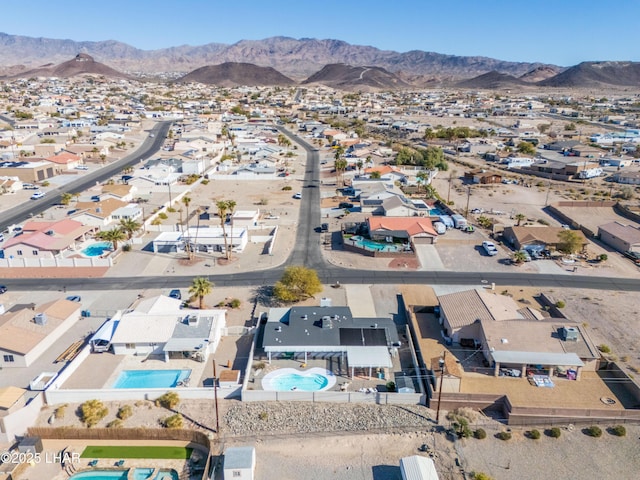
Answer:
[{"left": 110, "top": 295, "right": 226, "bottom": 362}]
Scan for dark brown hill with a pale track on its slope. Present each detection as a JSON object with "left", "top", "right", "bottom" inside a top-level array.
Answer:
[{"left": 302, "top": 63, "right": 410, "bottom": 91}]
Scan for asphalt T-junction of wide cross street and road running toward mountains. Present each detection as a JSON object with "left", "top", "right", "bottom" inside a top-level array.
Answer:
[{"left": 5, "top": 125, "right": 640, "bottom": 291}]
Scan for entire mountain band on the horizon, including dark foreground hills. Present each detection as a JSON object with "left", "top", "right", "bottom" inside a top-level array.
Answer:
[{"left": 0, "top": 33, "right": 640, "bottom": 91}]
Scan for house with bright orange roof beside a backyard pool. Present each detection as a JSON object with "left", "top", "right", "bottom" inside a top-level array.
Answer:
[{"left": 367, "top": 217, "right": 438, "bottom": 244}]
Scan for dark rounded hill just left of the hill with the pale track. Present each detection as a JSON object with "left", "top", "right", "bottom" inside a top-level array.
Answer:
[{"left": 177, "top": 62, "right": 296, "bottom": 87}]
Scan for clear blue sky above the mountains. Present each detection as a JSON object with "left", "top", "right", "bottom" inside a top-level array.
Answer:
[{"left": 0, "top": 0, "right": 640, "bottom": 66}]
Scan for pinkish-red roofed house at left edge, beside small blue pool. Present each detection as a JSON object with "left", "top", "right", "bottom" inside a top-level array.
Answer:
[{"left": 2, "top": 218, "right": 97, "bottom": 259}]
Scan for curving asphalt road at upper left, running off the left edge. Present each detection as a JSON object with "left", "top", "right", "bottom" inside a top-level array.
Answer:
[{"left": 0, "top": 122, "right": 171, "bottom": 231}]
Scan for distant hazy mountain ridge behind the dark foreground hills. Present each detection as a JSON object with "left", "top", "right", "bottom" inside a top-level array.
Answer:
[{"left": 0, "top": 33, "right": 542, "bottom": 80}]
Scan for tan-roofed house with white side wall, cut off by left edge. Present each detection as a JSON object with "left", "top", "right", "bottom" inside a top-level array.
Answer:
[{"left": 0, "top": 299, "right": 81, "bottom": 368}]
